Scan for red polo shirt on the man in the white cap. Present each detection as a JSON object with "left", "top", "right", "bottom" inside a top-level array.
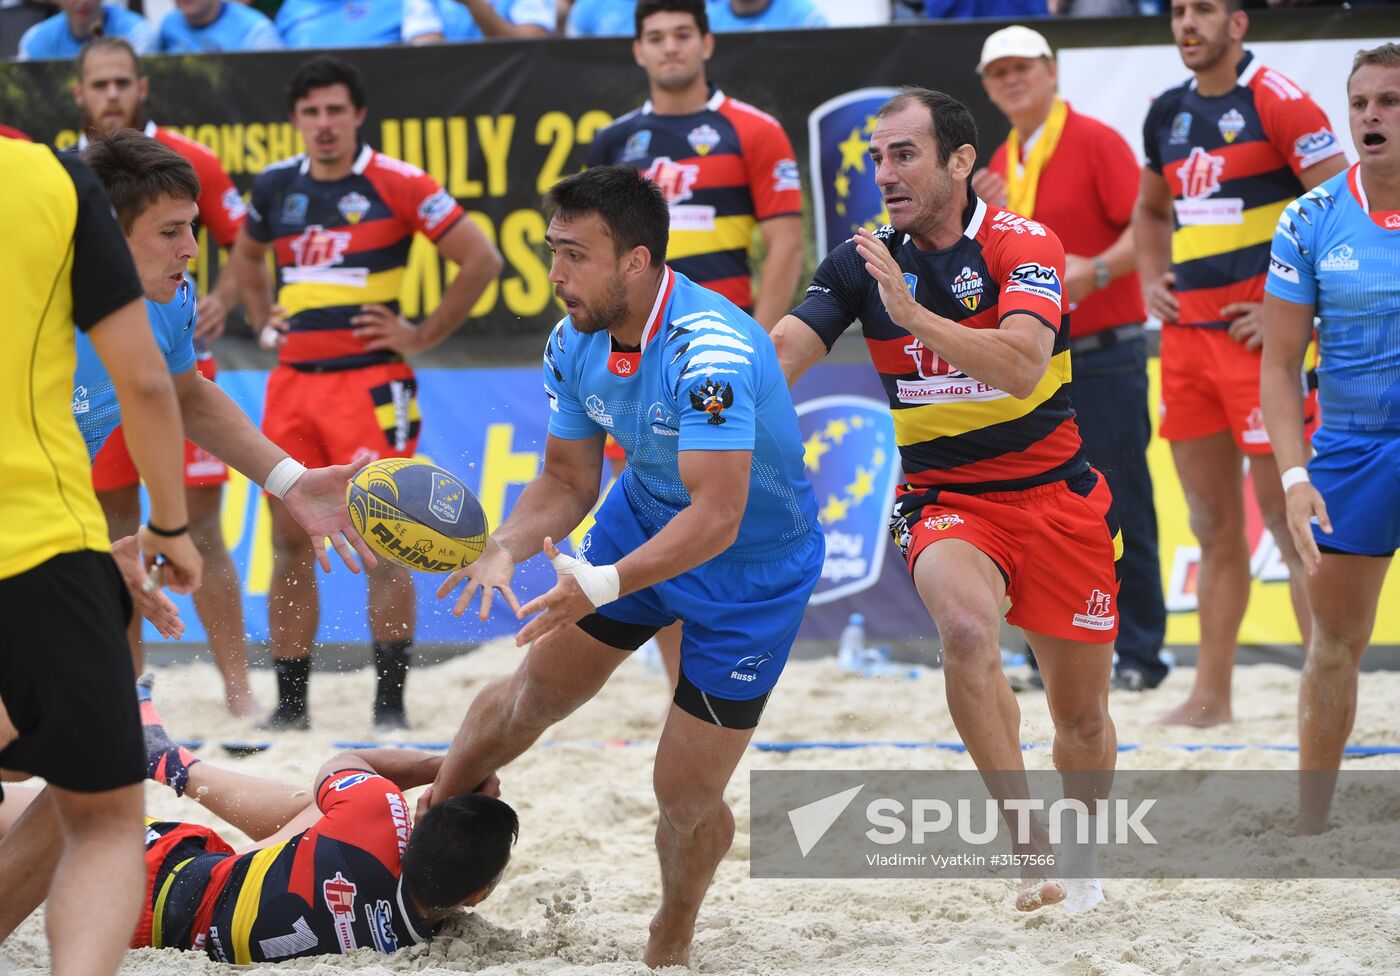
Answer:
[{"left": 988, "top": 108, "right": 1147, "bottom": 339}]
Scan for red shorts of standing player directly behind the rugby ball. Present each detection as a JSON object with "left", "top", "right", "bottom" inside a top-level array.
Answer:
[{"left": 263, "top": 363, "right": 419, "bottom": 468}]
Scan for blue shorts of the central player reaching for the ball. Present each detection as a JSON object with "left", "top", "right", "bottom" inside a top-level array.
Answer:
[{"left": 578, "top": 490, "right": 826, "bottom": 702}]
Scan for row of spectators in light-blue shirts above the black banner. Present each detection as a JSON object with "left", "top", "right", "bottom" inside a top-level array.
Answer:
[{"left": 0, "top": 0, "right": 1393, "bottom": 60}]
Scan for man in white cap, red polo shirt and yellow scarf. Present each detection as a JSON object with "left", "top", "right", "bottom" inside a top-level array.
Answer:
[{"left": 973, "top": 25, "right": 1166, "bottom": 690}]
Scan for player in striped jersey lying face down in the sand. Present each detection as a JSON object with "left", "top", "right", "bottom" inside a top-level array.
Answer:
[{"left": 0, "top": 683, "right": 518, "bottom": 963}]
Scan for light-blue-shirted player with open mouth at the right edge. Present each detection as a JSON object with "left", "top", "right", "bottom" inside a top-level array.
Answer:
[{"left": 1263, "top": 43, "right": 1400, "bottom": 833}]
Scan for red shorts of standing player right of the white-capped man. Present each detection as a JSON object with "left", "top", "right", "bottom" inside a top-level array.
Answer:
[{"left": 1161, "top": 325, "right": 1319, "bottom": 454}]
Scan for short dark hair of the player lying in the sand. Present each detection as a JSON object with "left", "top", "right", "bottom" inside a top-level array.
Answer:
[{"left": 402, "top": 793, "right": 521, "bottom": 913}]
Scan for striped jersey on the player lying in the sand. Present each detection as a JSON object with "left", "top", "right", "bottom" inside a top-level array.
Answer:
[{"left": 151, "top": 769, "right": 431, "bottom": 963}]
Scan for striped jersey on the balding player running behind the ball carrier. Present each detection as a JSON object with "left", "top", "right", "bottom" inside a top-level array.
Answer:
[{"left": 792, "top": 197, "right": 1089, "bottom": 493}]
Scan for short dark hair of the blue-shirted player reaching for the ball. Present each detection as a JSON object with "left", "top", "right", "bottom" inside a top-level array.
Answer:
[{"left": 545, "top": 167, "right": 671, "bottom": 267}]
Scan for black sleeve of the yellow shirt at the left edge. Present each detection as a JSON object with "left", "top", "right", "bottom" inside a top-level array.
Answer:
[{"left": 55, "top": 153, "right": 143, "bottom": 332}]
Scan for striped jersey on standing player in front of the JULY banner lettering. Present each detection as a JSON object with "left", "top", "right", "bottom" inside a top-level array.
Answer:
[{"left": 248, "top": 146, "right": 465, "bottom": 370}]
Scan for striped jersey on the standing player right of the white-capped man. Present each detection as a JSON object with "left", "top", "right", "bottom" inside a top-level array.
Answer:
[{"left": 1142, "top": 53, "right": 1344, "bottom": 329}]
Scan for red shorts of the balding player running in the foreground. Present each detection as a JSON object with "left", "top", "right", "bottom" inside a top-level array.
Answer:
[{"left": 892, "top": 470, "right": 1123, "bottom": 644}]
